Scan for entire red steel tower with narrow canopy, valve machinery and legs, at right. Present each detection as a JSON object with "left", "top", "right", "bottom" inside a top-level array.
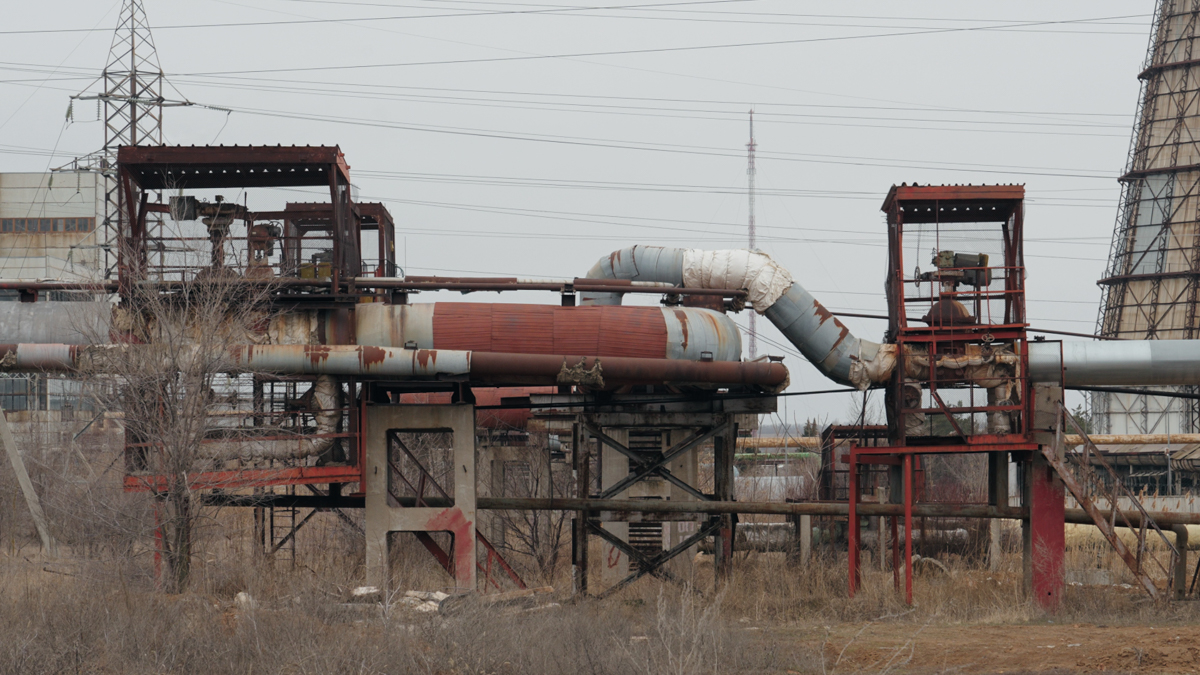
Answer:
[{"left": 850, "top": 185, "right": 1063, "bottom": 605}]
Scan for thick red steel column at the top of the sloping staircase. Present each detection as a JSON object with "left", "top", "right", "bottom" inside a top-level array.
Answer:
[{"left": 1025, "top": 453, "right": 1067, "bottom": 611}]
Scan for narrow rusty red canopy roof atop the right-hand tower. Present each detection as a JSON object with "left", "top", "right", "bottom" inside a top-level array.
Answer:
[{"left": 881, "top": 185, "right": 1025, "bottom": 222}]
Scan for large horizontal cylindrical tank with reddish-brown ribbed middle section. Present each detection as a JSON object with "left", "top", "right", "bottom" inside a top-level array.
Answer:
[{"left": 354, "top": 303, "right": 742, "bottom": 362}]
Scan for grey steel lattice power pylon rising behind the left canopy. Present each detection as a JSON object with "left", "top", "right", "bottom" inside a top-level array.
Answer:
[{"left": 71, "top": 0, "right": 166, "bottom": 279}]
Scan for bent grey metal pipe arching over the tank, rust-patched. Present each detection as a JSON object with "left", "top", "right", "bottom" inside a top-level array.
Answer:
[{"left": 580, "top": 246, "right": 887, "bottom": 389}]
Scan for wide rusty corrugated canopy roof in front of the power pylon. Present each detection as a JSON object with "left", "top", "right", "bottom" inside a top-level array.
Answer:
[{"left": 116, "top": 145, "right": 350, "bottom": 190}]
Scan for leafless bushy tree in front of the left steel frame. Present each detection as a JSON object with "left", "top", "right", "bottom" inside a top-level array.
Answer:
[{"left": 80, "top": 273, "right": 278, "bottom": 592}]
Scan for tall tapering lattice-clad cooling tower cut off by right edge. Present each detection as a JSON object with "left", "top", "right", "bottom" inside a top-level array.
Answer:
[{"left": 1092, "top": 0, "right": 1200, "bottom": 434}]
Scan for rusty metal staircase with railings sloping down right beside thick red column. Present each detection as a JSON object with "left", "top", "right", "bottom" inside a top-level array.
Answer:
[{"left": 1042, "top": 402, "right": 1180, "bottom": 598}]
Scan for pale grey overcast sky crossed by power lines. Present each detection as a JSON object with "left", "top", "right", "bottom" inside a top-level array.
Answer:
[{"left": 0, "top": 0, "right": 1154, "bottom": 420}]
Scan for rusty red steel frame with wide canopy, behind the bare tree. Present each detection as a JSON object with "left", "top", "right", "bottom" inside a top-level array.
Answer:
[{"left": 116, "top": 145, "right": 381, "bottom": 496}]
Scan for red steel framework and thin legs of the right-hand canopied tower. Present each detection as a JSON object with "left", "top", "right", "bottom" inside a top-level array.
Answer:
[{"left": 848, "top": 185, "right": 1046, "bottom": 603}]
